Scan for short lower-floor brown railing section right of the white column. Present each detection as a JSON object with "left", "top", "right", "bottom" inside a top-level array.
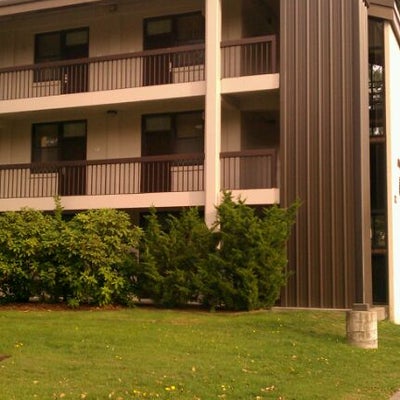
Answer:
[{"left": 220, "top": 149, "right": 278, "bottom": 190}]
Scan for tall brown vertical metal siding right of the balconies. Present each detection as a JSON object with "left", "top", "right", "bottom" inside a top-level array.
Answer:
[{"left": 280, "top": 0, "right": 370, "bottom": 308}]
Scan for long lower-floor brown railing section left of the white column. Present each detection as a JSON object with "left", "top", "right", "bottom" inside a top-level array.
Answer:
[{"left": 0, "top": 154, "right": 204, "bottom": 199}]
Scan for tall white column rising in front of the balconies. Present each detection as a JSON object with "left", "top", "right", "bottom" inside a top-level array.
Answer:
[{"left": 204, "top": 0, "right": 222, "bottom": 225}]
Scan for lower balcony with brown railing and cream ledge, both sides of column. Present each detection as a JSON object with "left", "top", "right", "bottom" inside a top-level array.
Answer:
[{"left": 0, "top": 148, "right": 279, "bottom": 211}]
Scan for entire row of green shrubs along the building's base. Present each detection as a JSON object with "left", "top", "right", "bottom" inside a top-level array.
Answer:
[{"left": 0, "top": 193, "right": 299, "bottom": 310}]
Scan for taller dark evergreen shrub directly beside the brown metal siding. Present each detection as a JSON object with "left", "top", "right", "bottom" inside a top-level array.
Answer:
[{"left": 204, "top": 193, "right": 298, "bottom": 310}]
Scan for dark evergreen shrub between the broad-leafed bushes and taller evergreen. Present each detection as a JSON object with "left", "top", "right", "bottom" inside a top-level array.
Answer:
[{"left": 136, "top": 208, "right": 214, "bottom": 307}]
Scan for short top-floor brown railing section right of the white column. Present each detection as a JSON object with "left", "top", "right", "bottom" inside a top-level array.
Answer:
[{"left": 221, "top": 35, "right": 278, "bottom": 78}]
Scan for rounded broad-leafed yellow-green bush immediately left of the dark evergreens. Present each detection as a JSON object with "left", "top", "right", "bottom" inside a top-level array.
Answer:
[{"left": 58, "top": 209, "right": 141, "bottom": 305}]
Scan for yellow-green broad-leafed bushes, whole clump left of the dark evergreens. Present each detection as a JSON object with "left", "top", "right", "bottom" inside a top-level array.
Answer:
[{"left": 0, "top": 201, "right": 141, "bottom": 305}]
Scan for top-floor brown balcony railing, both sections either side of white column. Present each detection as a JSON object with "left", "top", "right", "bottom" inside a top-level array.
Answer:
[{"left": 0, "top": 35, "right": 278, "bottom": 100}]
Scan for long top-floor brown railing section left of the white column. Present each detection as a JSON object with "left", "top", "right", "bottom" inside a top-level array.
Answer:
[{"left": 0, "top": 44, "right": 204, "bottom": 100}]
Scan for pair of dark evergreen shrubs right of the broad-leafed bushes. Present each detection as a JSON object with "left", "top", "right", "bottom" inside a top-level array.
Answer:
[{"left": 139, "top": 193, "right": 298, "bottom": 310}]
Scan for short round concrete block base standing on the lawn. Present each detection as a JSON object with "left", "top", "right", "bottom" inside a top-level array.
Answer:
[{"left": 346, "top": 310, "right": 378, "bottom": 349}]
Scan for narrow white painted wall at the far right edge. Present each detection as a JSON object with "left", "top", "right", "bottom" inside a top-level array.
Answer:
[{"left": 385, "top": 23, "right": 400, "bottom": 324}]
